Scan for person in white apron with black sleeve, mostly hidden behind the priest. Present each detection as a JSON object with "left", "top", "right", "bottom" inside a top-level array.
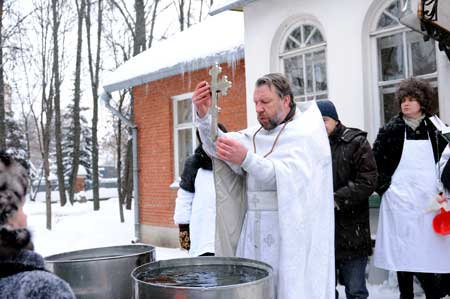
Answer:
[{"left": 174, "top": 123, "right": 226, "bottom": 256}]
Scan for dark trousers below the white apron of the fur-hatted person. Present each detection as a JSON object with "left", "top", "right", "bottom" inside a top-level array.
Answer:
[{"left": 397, "top": 271, "right": 441, "bottom": 299}]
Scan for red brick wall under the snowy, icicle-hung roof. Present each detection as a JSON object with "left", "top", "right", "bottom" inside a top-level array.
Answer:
[{"left": 133, "top": 60, "right": 247, "bottom": 230}]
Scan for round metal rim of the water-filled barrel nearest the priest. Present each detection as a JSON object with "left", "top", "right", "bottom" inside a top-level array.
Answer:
[{"left": 131, "top": 256, "right": 273, "bottom": 292}]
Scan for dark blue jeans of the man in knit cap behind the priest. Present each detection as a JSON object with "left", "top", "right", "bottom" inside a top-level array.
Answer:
[{"left": 336, "top": 257, "right": 369, "bottom": 299}]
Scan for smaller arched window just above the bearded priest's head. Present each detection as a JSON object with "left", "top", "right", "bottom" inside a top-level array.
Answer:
[{"left": 279, "top": 23, "right": 328, "bottom": 101}]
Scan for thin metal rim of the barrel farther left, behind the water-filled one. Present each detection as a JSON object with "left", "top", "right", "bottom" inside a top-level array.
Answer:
[{"left": 44, "top": 243, "right": 155, "bottom": 264}]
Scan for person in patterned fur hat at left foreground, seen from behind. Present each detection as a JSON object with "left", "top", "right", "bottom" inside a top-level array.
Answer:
[{"left": 0, "top": 151, "right": 75, "bottom": 299}]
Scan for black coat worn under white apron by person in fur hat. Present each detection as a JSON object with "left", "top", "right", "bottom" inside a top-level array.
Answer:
[{"left": 373, "top": 113, "right": 447, "bottom": 196}]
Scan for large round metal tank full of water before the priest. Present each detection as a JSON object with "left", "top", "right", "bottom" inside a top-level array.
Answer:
[{"left": 131, "top": 257, "right": 275, "bottom": 299}]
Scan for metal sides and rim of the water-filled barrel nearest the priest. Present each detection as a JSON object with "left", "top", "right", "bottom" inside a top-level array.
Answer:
[{"left": 131, "top": 257, "right": 275, "bottom": 299}]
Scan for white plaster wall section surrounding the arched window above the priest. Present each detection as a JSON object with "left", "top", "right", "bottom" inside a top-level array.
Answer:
[{"left": 244, "top": 0, "right": 370, "bottom": 128}]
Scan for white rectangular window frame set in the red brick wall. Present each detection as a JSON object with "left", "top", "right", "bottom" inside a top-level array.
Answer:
[{"left": 170, "top": 92, "right": 197, "bottom": 188}]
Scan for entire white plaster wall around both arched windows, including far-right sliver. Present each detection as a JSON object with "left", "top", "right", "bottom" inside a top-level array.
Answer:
[{"left": 244, "top": 0, "right": 450, "bottom": 140}]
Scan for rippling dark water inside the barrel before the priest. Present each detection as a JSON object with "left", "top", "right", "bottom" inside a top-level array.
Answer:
[{"left": 137, "top": 264, "right": 268, "bottom": 288}]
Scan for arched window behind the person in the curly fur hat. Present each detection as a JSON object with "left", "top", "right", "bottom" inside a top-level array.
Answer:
[{"left": 370, "top": 0, "right": 439, "bottom": 125}]
